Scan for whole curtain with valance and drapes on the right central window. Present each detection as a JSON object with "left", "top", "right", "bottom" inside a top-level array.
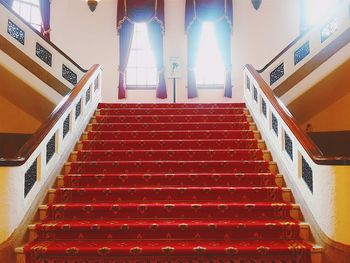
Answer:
[{"left": 185, "top": 0, "right": 233, "bottom": 98}]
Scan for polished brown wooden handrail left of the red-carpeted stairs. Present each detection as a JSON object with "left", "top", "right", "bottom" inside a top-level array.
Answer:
[{"left": 0, "top": 65, "right": 101, "bottom": 166}]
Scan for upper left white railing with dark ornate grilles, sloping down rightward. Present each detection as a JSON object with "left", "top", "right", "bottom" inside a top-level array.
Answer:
[{"left": 0, "top": 0, "right": 86, "bottom": 89}]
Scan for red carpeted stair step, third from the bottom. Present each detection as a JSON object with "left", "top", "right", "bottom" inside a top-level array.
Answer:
[{"left": 39, "top": 202, "right": 301, "bottom": 220}]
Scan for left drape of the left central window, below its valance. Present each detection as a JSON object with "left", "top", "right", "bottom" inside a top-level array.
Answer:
[{"left": 118, "top": 20, "right": 134, "bottom": 99}]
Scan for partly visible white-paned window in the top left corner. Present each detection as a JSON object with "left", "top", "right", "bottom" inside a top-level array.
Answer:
[{"left": 12, "top": 0, "right": 42, "bottom": 31}]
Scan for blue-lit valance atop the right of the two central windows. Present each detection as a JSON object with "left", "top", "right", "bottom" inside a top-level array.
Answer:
[{"left": 185, "top": 0, "right": 233, "bottom": 32}]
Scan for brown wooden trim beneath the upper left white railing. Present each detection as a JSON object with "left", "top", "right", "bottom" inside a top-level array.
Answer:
[{"left": 0, "top": 35, "right": 70, "bottom": 96}]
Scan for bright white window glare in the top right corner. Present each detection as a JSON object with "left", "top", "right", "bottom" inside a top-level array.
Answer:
[{"left": 306, "top": 0, "right": 335, "bottom": 26}]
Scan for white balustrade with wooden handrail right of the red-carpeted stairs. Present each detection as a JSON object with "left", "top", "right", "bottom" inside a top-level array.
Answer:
[{"left": 244, "top": 65, "right": 350, "bottom": 248}]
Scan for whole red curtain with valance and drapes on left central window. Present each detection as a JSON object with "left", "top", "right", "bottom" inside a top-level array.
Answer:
[{"left": 117, "top": 0, "right": 167, "bottom": 99}]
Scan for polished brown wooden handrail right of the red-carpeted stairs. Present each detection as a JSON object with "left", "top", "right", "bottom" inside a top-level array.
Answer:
[{"left": 245, "top": 65, "right": 350, "bottom": 165}]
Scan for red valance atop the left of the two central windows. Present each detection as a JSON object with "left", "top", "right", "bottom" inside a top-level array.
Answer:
[{"left": 117, "top": 0, "right": 165, "bottom": 32}]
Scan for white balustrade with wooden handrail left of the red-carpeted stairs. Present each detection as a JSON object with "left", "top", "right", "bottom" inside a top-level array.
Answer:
[{"left": 0, "top": 65, "right": 102, "bottom": 243}]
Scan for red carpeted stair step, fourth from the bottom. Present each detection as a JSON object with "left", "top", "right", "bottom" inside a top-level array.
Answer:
[{"left": 48, "top": 187, "right": 292, "bottom": 203}]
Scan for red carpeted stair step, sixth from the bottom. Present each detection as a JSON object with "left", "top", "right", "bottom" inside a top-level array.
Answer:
[{"left": 64, "top": 161, "right": 277, "bottom": 174}]
